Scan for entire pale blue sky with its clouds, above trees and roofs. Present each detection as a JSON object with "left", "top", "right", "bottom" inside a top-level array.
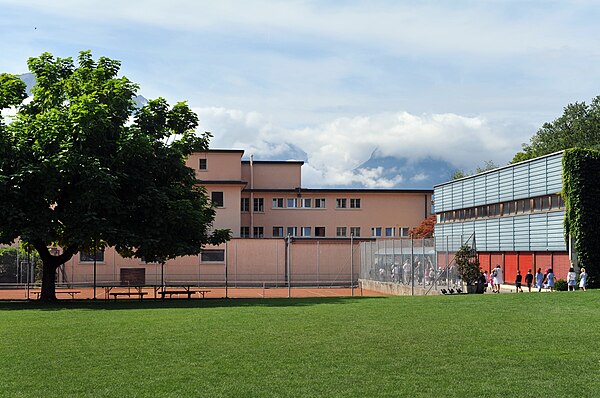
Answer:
[{"left": 0, "top": 0, "right": 600, "bottom": 187}]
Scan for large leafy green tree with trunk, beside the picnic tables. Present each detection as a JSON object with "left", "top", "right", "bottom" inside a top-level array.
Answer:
[{"left": 0, "top": 51, "right": 230, "bottom": 300}]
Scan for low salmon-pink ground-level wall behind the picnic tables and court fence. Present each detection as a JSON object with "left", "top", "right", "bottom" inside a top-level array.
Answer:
[{"left": 61, "top": 239, "right": 360, "bottom": 285}]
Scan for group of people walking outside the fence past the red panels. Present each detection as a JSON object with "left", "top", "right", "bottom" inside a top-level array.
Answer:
[{"left": 483, "top": 265, "right": 587, "bottom": 293}]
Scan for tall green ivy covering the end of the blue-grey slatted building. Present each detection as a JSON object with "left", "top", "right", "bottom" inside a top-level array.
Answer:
[{"left": 562, "top": 148, "right": 600, "bottom": 287}]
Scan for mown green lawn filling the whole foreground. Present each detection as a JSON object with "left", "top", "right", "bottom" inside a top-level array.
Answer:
[{"left": 0, "top": 291, "right": 600, "bottom": 397}]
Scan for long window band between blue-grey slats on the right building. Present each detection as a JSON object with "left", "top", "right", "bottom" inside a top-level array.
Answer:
[{"left": 437, "top": 194, "right": 565, "bottom": 223}]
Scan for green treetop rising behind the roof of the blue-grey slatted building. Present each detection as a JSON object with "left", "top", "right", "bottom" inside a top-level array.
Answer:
[{"left": 511, "top": 96, "right": 600, "bottom": 163}]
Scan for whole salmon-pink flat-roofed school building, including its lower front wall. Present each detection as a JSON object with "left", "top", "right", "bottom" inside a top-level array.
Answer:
[{"left": 64, "top": 149, "right": 433, "bottom": 285}]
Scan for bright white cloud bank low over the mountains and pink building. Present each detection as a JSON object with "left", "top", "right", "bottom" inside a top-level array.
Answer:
[{"left": 196, "top": 108, "right": 521, "bottom": 188}]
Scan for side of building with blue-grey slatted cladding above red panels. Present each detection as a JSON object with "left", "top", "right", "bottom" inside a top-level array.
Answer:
[{"left": 434, "top": 152, "right": 570, "bottom": 282}]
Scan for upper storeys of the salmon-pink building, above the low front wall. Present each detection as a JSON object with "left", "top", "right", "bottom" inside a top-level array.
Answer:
[{"left": 187, "top": 150, "right": 433, "bottom": 238}]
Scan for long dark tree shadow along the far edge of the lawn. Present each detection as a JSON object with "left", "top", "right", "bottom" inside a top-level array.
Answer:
[{"left": 0, "top": 296, "right": 387, "bottom": 311}]
